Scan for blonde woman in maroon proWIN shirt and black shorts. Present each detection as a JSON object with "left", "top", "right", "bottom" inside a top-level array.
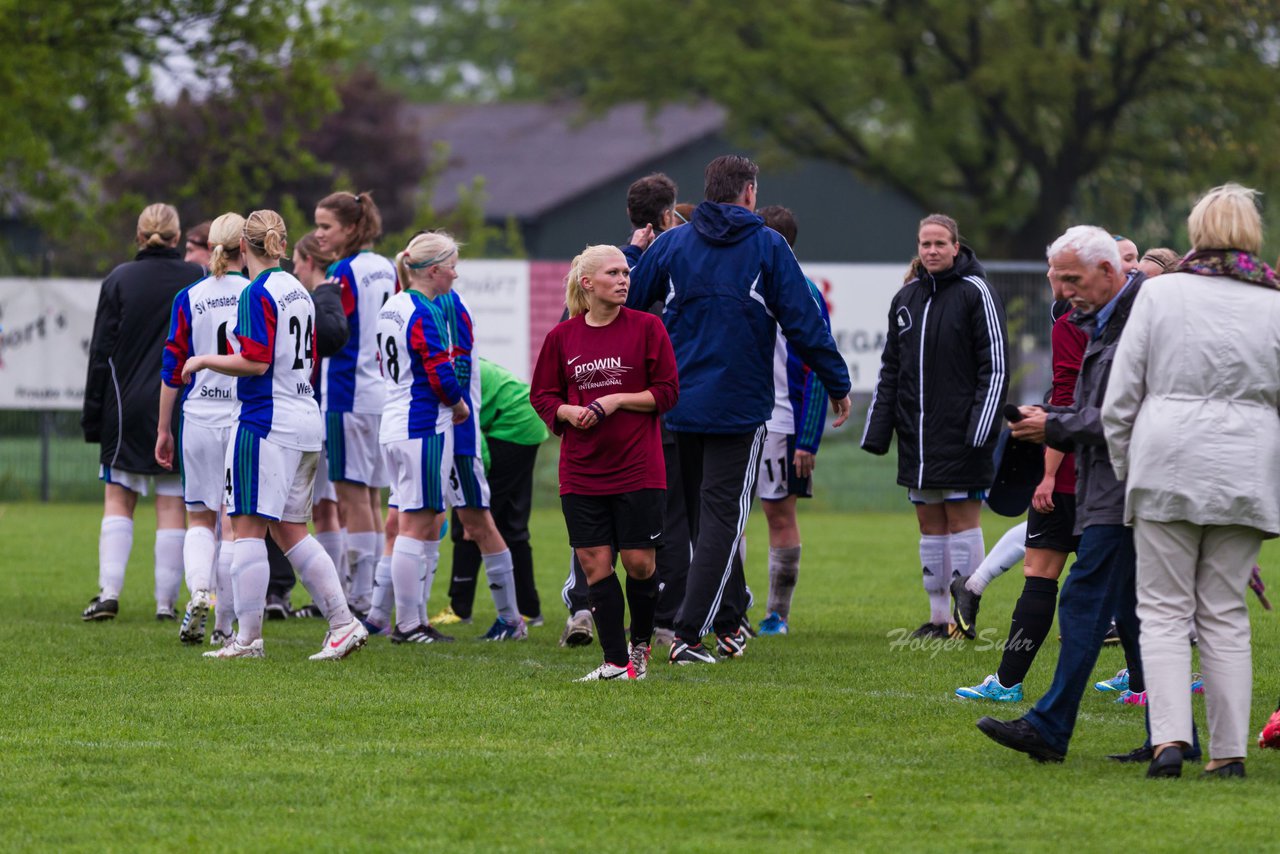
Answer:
[{"left": 529, "top": 246, "right": 678, "bottom": 681}]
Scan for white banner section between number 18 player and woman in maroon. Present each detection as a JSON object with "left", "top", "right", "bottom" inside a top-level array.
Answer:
[{"left": 453, "top": 260, "right": 532, "bottom": 383}]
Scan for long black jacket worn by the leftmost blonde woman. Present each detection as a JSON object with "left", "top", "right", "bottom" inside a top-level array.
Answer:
[{"left": 81, "top": 247, "right": 205, "bottom": 475}]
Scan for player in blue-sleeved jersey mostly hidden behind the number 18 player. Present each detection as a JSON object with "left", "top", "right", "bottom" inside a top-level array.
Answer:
[{"left": 426, "top": 236, "right": 529, "bottom": 640}]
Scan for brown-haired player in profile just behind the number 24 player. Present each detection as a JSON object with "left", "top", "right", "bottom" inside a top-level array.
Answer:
[{"left": 315, "top": 193, "right": 399, "bottom": 616}]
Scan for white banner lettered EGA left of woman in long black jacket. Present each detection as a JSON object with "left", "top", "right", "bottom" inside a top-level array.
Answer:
[{"left": 803, "top": 262, "right": 906, "bottom": 393}]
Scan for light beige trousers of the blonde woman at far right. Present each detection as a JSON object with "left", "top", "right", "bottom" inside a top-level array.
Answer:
[{"left": 1133, "top": 519, "right": 1262, "bottom": 759}]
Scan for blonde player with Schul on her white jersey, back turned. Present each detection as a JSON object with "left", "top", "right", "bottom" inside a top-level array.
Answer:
[{"left": 155, "top": 214, "right": 248, "bottom": 645}]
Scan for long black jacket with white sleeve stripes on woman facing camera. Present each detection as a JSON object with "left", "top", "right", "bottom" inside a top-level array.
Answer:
[{"left": 863, "top": 246, "right": 1009, "bottom": 490}]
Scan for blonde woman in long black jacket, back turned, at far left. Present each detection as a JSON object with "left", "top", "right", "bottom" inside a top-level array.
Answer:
[{"left": 81, "top": 205, "right": 204, "bottom": 620}]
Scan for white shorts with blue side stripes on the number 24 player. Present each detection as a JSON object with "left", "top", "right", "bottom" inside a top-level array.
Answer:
[{"left": 225, "top": 426, "right": 320, "bottom": 522}]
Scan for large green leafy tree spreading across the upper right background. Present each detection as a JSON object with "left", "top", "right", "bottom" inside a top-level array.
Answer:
[{"left": 504, "top": 0, "right": 1280, "bottom": 257}]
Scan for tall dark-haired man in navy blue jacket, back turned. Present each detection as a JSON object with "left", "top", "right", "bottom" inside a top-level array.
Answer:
[{"left": 627, "top": 155, "right": 850, "bottom": 665}]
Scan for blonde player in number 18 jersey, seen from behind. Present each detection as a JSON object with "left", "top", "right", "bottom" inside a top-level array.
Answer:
[{"left": 378, "top": 233, "right": 470, "bottom": 644}]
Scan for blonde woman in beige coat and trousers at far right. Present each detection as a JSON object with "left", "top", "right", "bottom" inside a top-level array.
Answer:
[{"left": 1102, "top": 184, "right": 1280, "bottom": 777}]
